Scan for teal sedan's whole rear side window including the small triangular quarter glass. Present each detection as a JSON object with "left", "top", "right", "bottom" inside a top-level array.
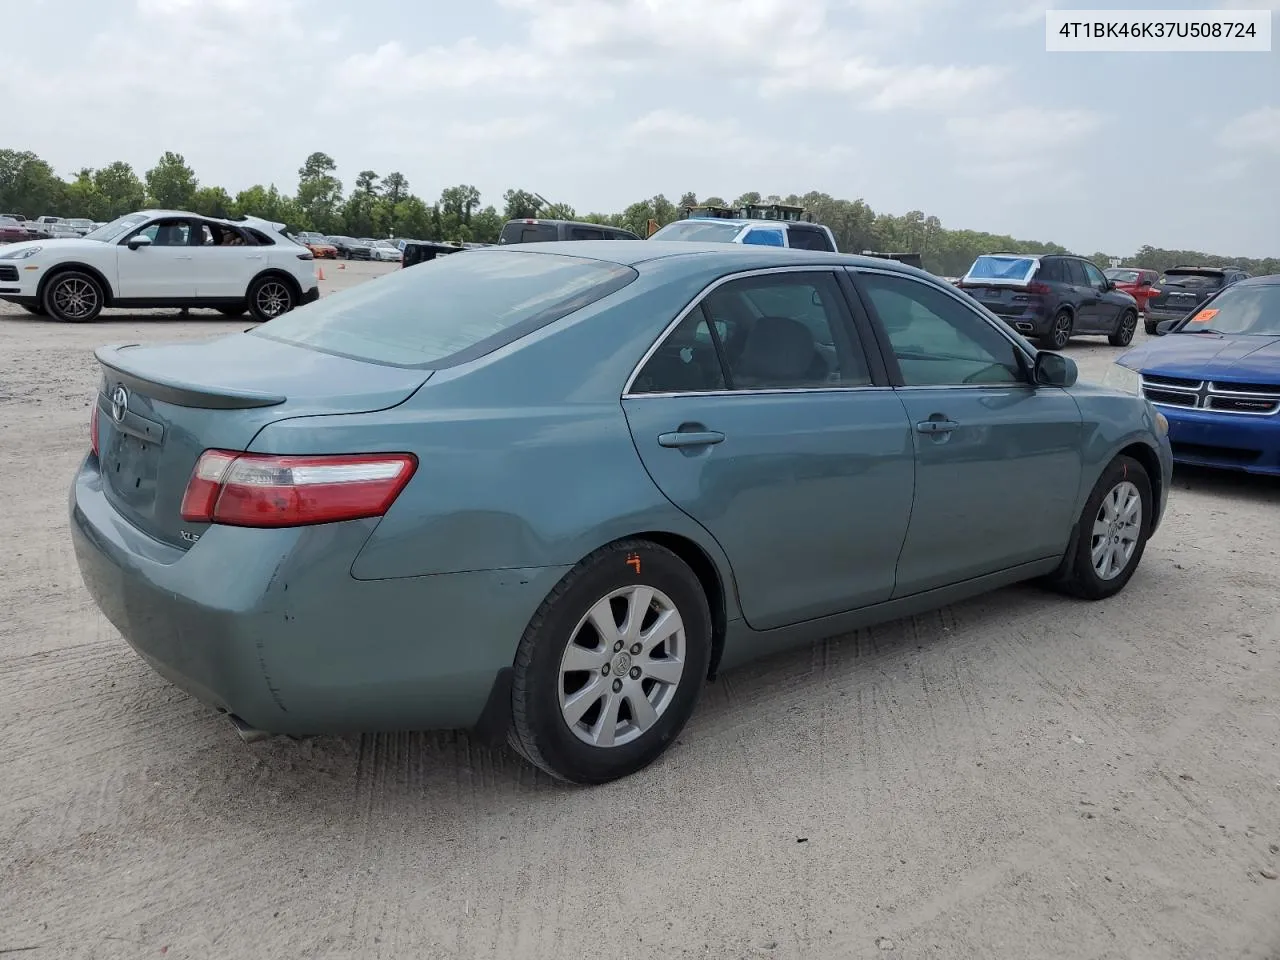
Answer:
[{"left": 631, "top": 273, "right": 872, "bottom": 393}]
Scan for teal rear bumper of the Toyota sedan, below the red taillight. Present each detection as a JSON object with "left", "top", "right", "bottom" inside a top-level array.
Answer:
[{"left": 69, "top": 454, "right": 567, "bottom": 735}]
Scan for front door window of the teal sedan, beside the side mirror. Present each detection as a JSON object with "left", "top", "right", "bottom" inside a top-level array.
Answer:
[{"left": 860, "top": 274, "right": 1025, "bottom": 387}]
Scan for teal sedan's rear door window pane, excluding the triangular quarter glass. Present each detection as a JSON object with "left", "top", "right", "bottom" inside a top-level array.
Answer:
[{"left": 703, "top": 273, "right": 870, "bottom": 390}]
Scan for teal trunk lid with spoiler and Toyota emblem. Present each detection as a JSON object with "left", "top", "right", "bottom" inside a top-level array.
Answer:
[{"left": 96, "top": 334, "right": 431, "bottom": 547}]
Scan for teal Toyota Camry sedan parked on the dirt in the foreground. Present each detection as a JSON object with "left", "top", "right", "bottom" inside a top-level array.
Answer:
[{"left": 69, "top": 241, "right": 1172, "bottom": 783}]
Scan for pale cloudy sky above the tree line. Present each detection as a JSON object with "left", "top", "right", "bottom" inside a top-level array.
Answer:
[{"left": 0, "top": 0, "right": 1280, "bottom": 256}]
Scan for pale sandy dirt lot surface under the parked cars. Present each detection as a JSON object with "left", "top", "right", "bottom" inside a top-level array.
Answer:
[{"left": 0, "top": 264, "right": 1280, "bottom": 960}]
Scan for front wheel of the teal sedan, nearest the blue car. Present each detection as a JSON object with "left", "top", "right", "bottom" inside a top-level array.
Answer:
[{"left": 1055, "top": 456, "right": 1155, "bottom": 600}]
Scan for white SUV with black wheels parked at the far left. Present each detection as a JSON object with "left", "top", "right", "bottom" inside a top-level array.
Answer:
[{"left": 0, "top": 210, "right": 320, "bottom": 323}]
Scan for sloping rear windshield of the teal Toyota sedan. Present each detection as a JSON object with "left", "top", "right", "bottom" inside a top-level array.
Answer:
[{"left": 252, "top": 250, "right": 637, "bottom": 367}]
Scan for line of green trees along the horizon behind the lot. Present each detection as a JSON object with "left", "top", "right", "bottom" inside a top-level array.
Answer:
[{"left": 0, "top": 148, "right": 1280, "bottom": 276}]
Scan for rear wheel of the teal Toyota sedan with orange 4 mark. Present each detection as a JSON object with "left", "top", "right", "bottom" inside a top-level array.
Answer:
[{"left": 508, "top": 540, "right": 712, "bottom": 783}]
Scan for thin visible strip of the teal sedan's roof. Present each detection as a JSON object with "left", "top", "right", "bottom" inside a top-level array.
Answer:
[{"left": 476, "top": 239, "right": 938, "bottom": 279}]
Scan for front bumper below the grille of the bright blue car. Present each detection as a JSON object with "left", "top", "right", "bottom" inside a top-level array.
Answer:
[{"left": 1157, "top": 404, "right": 1280, "bottom": 476}]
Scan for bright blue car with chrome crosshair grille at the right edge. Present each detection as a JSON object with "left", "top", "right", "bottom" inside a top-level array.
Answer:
[{"left": 1117, "top": 275, "right": 1280, "bottom": 475}]
